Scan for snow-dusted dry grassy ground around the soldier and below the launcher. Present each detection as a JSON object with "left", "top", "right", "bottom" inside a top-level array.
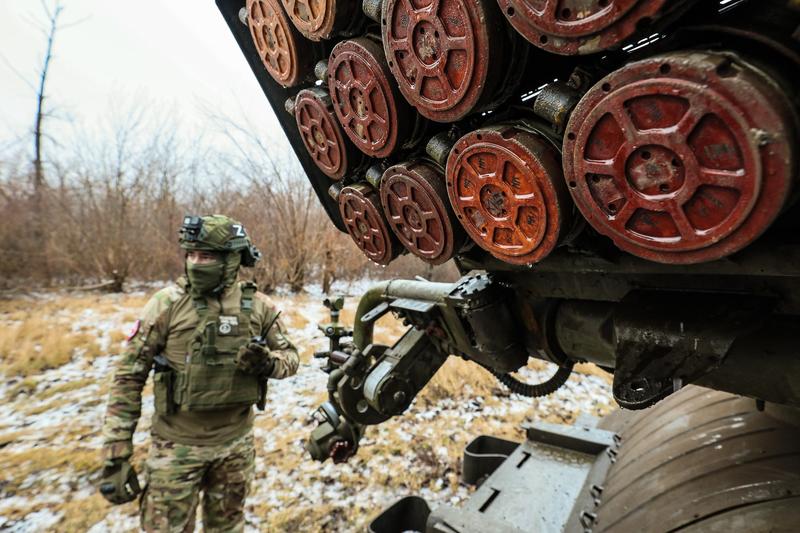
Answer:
[{"left": 0, "top": 282, "right": 612, "bottom": 533}]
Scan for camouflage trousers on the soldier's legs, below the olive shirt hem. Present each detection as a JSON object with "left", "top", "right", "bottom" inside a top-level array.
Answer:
[{"left": 140, "top": 431, "right": 256, "bottom": 533}]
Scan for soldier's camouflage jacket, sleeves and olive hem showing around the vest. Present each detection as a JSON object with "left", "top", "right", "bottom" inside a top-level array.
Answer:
[{"left": 102, "top": 279, "right": 299, "bottom": 458}]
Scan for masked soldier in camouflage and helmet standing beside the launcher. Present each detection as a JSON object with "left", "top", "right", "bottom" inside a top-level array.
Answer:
[{"left": 100, "top": 215, "right": 298, "bottom": 531}]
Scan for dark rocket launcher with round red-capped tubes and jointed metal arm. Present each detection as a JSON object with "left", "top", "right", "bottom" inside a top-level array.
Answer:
[{"left": 217, "top": 0, "right": 800, "bottom": 531}]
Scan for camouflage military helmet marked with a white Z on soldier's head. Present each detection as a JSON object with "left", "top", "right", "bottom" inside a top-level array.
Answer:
[{"left": 179, "top": 215, "right": 261, "bottom": 267}]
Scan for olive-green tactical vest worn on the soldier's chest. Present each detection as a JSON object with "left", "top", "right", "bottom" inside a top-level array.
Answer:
[{"left": 154, "top": 282, "right": 266, "bottom": 414}]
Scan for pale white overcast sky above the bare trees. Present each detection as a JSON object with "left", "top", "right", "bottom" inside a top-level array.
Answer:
[{"left": 0, "top": 0, "right": 288, "bottom": 160}]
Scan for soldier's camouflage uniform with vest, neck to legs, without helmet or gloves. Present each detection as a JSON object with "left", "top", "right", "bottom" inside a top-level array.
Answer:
[{"left": 103, "top": 214, "right": 299, "bottom": 531}]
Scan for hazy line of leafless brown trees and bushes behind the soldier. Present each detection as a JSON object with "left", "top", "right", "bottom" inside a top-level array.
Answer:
[{"left": 0, "top": 106, "right": 453, "bottom": 291}]
